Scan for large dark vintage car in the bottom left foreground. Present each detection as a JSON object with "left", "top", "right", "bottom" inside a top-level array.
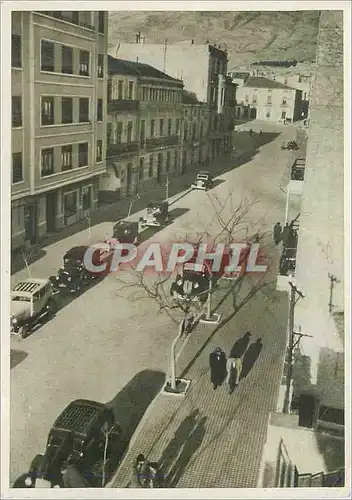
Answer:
[{"left": 30, "top": 399, "right": 127, "bottom": 487}]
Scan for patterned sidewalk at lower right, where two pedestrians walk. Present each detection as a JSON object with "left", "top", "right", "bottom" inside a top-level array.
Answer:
[{"left": 108, "top": 250, "right": 288, "bottom": 488}]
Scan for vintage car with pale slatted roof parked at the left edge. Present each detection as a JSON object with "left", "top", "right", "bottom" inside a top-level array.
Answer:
[{"left": 10, "top": 278, "right": 56, "bottom": 338}]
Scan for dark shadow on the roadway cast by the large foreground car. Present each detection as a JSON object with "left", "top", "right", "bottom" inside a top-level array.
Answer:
[{"left": 107, "top": 370, "right": 165, "bottom": 441}]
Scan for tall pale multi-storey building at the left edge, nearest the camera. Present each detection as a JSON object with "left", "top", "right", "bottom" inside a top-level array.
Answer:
[{"left": 11, "top": 11, "right": 108, "bottom": 254}]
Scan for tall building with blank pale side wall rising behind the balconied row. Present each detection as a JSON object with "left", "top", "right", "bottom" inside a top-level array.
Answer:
[{"left": 111, "top": 40, "right": 235, "bottom": 157}]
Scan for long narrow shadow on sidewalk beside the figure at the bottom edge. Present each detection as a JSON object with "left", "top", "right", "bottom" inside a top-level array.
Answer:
[{"left": 166, "top": 417, "right": 207, "bottom": 488}]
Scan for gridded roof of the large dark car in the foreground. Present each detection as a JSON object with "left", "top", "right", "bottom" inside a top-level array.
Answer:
[{"left": 52, "top": 399, "right": 107, "bottom": 435}]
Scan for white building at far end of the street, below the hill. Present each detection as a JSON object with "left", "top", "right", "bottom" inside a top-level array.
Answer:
[{"left": 236, "top": 76, "right": 302, "bottom": 122}]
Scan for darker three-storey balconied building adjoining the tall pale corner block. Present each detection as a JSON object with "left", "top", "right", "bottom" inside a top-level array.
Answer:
[{"left": 100, "top": 56, "right": 183, "bottom": 201}]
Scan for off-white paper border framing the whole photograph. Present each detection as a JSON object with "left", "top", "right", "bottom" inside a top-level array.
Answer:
[{"left": 1, "top": 0, "right": 351, "bottom": 499}]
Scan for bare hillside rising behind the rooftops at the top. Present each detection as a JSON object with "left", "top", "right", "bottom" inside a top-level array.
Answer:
[{"left": 109, "top": 11, "right": 319, "bottom": 69}]
